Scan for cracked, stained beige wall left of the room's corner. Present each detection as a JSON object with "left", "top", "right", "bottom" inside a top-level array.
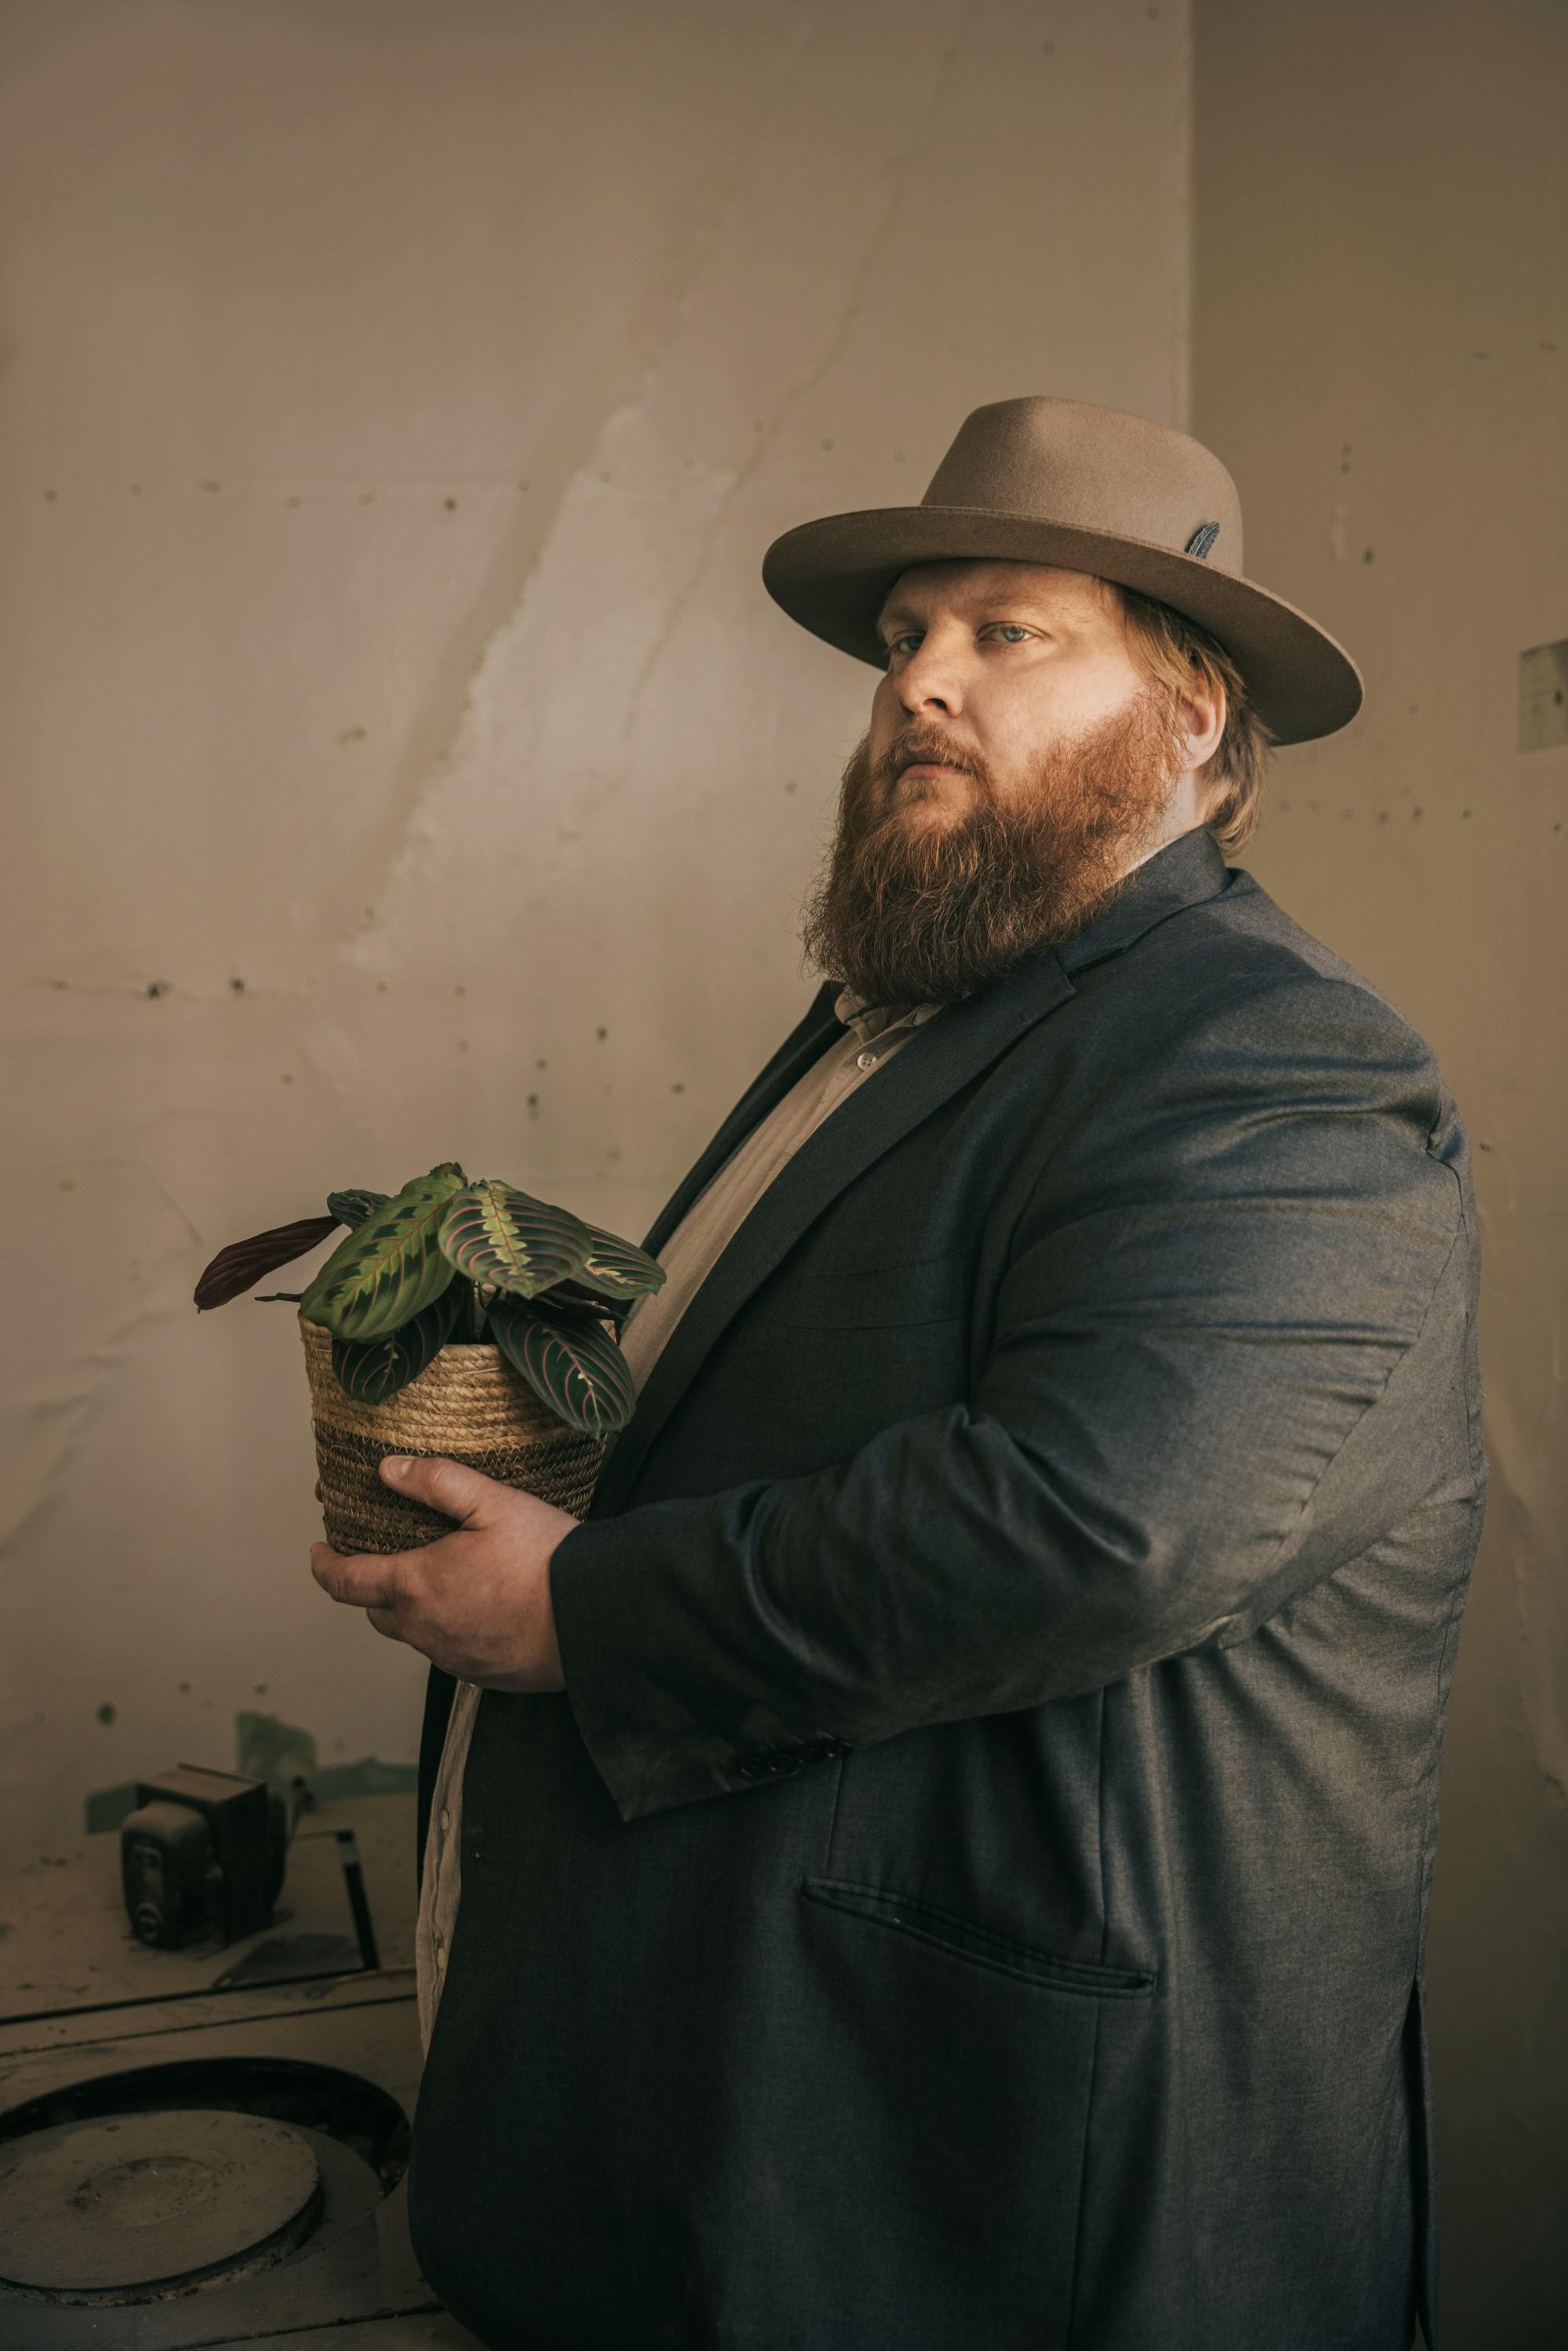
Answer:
[{"left": 0, "top": 0, "right": 1187, "bottom": 1838}]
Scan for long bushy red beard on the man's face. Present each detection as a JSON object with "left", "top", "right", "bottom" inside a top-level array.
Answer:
[{"left": 801, "top": 691, "right": 1180, "bottom": 1004}]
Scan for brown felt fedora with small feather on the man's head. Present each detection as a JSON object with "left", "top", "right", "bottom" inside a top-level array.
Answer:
[{"left": 762, "top": 398, "right": 1361, "bottom": 743}]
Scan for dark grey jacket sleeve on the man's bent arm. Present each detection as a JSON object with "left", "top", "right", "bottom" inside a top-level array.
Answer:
[{"left": 550, "top": 973, "right": 1462, "bottom": 1819}]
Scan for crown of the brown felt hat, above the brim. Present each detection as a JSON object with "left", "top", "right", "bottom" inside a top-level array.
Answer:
[{"left": 921, "top": 395, "right": 1241, "bottom": 576}]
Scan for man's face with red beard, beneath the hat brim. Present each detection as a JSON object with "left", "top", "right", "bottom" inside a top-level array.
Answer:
[{"left": 801, "top": 562, "right": 1201, "bottom": 1004}]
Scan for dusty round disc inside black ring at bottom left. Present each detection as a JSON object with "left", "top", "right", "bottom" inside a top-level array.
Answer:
[{"left": 0, "top": 2106, "right": 322, "bottom": 2295}]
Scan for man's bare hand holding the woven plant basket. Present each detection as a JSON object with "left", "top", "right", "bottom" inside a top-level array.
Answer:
[{"left": 310, "top": 1455, "right": 579, "bottom": 1691}]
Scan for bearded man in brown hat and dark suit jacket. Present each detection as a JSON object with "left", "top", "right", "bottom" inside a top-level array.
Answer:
[{"left": 315, "top": 400, "right": 1486, "bottom": 2351}]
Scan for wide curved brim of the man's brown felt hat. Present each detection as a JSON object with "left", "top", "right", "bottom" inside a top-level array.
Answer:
[{"left": 762, "top": 506, "right": 1363, "bottom": 743}]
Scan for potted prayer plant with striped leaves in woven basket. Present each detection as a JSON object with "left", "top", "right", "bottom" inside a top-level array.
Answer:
[{"left": 195, "top": 1159, "right": 666, "bottom": 1552}]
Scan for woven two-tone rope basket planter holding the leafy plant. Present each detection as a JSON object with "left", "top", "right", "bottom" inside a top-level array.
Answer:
[{"left": 299, "top": 1314, "right": 609, "bottom": 1552}]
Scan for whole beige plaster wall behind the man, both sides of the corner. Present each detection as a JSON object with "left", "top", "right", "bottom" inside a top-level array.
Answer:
[{"left": 0, "top": 0, "right": 1568, "bottom": 2313}]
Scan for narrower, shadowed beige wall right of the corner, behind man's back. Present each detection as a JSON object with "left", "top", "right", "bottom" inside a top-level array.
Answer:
[{"left": 1194, "top": 0, "right": 1568, "bottom": 2351}]
